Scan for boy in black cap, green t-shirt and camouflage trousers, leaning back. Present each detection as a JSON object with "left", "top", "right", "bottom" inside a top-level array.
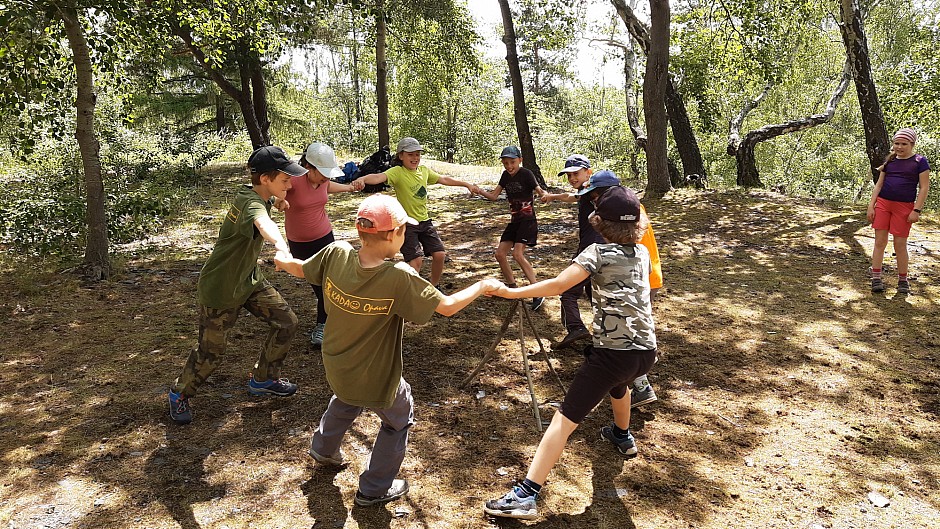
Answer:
[{"left": 169, "top": 147, "right": 307, "bottom": 424}]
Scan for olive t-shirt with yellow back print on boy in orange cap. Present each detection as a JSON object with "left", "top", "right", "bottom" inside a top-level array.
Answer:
[{"left": 303, "top": 241, "right": 444, "bottom": 408}]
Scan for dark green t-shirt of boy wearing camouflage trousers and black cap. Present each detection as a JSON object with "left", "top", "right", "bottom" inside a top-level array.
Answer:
[{"left": 197, "top": 186, "right": 271, "bottom": 309}]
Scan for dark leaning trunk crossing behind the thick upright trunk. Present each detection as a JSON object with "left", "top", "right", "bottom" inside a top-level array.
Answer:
[{"left": 612, "top": 0, "right": 707, "bottom": 181}]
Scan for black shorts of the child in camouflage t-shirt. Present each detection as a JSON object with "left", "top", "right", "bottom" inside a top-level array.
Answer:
[{"left": 561, "top": 346, "right": 656, "bottom": 424}]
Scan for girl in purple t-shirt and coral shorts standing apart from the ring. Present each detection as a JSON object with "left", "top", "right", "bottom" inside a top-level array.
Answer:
[{"left": 868, "top": 128, "right": 930, "bottom": 294}]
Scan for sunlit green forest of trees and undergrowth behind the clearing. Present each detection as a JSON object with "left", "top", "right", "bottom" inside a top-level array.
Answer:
[{"left": 0, "top": 0, "right": 940, "bottom": 272}]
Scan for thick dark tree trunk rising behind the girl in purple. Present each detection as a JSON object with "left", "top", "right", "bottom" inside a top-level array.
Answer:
[{"left": 839, "top": 0, "right": 891, "bottom": 182}]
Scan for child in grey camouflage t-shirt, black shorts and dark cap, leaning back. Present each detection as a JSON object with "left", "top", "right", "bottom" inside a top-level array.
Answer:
[{"left": 483, "top": 187, "right": 656, "bottom": 519}]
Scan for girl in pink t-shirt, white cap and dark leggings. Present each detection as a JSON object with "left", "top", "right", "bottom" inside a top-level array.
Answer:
[{"left": 284, "top": 143, "right": 362, "bottom": 347}]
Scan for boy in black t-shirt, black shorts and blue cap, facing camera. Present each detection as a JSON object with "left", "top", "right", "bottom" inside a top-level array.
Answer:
[{"left": 473, "top": 145, "right": 545, "bottom": 310}]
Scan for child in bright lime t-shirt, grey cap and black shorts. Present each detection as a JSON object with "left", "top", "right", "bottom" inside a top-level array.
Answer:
[{"left": 356, "top": 138, "right": 482, "bottom": 287}]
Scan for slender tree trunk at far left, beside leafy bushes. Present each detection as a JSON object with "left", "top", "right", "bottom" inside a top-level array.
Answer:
[{"left": 58, "top": 7, "right": 111, "bottom": 280}]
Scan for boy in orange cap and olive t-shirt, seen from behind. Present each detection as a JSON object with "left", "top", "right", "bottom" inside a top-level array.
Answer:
[{"left": 274, "top": 194, "right": 502, "bottom": 506}]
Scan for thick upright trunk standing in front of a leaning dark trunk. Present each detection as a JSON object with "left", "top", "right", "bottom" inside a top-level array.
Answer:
[{"left": 643, "top": 0, "right": 672, "bottom": 197}]
